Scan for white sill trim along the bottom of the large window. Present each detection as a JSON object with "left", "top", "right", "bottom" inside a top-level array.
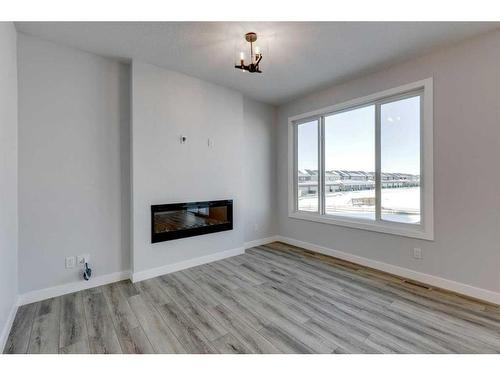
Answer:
[{"left": 288, "top": 211, "right": 434, "bottom": 241}]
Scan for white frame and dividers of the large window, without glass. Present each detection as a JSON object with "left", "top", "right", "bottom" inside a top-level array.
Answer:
[{"left": 288, "top": 78, "right": 434, "bottom": 241}]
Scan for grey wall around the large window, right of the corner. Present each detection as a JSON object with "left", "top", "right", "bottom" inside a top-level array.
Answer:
[{"left": 277, "top": 32, "right": 500, "bottom": 292}]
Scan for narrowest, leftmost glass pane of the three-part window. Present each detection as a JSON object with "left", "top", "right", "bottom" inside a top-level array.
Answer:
[{"left": 297, "top": 120, "right": 319, "bottom": 212}]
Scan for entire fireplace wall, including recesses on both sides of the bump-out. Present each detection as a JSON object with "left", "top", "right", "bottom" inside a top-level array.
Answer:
[{"left": 14, "top": 34, "right": 276, "bottom": 293}]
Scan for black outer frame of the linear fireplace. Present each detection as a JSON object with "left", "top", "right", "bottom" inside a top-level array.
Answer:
[{"left": 151, "top": 199, "right": 233, "bottom": 243}]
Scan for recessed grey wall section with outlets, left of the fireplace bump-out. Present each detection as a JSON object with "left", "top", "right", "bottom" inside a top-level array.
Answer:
[{"left": 18, "top": 34, "right": 130, "bottom": 293}]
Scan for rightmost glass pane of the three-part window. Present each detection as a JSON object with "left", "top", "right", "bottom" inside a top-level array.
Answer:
[{"left": 380, "top": 96, "right": 421, "bottom": 224}]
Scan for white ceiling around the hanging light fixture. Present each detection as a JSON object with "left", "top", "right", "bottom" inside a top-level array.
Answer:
[{"left": 16, "top": 22, "right": 500, "bottom": 104}]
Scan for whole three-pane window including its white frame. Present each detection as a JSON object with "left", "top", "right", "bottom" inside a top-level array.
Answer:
[{"left": 289, "top": 79, "right": 433, "bottom": 239}]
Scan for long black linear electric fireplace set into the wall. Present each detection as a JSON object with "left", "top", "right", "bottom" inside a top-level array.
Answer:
[{"left": 151, "top": 200, "right": 233, "bottom": 243}]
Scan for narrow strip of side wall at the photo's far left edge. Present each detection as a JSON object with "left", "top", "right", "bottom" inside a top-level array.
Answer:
[{"left": 0, "top": 22, "right": 17, "bottom": 349}]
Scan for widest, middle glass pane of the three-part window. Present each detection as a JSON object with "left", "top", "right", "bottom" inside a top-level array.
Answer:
[{"left": 325, "top": 105, "right": 375, "bottom": 220}]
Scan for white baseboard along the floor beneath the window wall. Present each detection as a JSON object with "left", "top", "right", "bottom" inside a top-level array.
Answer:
[{"left": 276, "top": 236, "right": 500, "bottom": 305}]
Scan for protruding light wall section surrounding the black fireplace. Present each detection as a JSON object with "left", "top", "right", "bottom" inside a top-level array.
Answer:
[{"left": 132, "top": 61, "right": 248, "bottom": 273}]
